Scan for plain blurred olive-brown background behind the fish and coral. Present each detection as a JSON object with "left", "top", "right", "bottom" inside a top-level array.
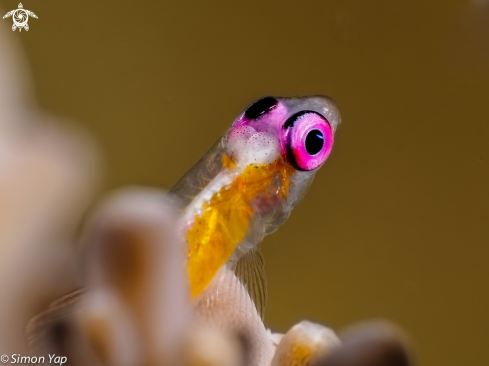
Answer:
[{"left": 0, "top": 0, "right": 489, "bottom": 366}]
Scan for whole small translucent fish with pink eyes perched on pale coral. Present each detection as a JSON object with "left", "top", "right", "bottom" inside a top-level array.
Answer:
[{"left": 171, "top": 96, "right": 340, "bottom": 297}]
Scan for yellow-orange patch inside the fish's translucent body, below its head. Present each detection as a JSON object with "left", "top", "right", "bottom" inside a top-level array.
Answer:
[{"left": 187, "top": 157, "right": 295, "bottom": 297}]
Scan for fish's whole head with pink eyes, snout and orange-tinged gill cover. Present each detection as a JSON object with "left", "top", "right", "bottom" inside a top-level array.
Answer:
[{"left": 222, "top": 96, "right": 341, "bottom": 227}]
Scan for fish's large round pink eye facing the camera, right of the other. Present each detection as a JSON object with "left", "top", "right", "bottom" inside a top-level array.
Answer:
[{"left": 283, "top": 111, "right": 333, "bottom": 170}]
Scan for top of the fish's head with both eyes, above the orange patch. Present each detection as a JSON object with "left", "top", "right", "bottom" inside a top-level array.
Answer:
[{"left": 226, "top": 96, "right": 340, "bottom": 172}]
